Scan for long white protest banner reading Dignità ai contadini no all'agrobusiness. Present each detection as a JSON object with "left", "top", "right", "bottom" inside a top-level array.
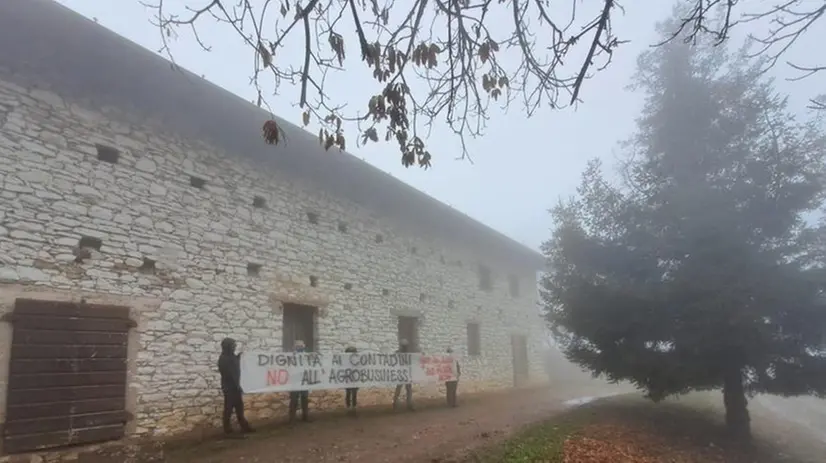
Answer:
[{"left": 241, "top": 352, "right": 456, "bottom": 393}]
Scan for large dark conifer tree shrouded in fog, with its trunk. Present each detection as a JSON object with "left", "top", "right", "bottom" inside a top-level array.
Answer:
[{"left": 542, "top": 14, "right": 826, "bottom": 437}]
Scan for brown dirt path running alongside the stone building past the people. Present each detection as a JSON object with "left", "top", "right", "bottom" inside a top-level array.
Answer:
[{"left": 166, "top": 382, "right": 627, "bottom": 463}]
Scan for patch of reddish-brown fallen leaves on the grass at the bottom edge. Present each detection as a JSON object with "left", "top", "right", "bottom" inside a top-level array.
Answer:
[{"left": 562, "top": 424, "right": 726, "bottom": 463}]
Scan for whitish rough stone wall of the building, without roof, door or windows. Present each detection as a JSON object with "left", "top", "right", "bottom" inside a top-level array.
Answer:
[{"left": 0, "top": 80, "right": 544, "bottom": 442}]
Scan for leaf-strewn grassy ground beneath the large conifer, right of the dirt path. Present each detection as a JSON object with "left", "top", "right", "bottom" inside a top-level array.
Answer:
[{"left": 467, "top": 394, "right": 823, "bottom": 463}]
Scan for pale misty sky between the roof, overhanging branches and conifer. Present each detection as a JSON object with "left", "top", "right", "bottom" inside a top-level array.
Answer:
[{"left": 54, "top": 0, "right": 826, "bottom": 254}]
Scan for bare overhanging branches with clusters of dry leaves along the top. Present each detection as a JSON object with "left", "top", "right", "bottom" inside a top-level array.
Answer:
[{"left": 144, "top": 0, "right": 826, "bottom": 168}]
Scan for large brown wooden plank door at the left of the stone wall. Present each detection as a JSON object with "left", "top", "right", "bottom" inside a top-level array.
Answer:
[{"left": 2, "top": 299, "right": 133, "bottom": 453}]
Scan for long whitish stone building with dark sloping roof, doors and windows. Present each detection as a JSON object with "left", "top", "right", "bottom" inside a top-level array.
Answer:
[{"left": 0, "top": 0, "right": 544, "bottom": 455}]
